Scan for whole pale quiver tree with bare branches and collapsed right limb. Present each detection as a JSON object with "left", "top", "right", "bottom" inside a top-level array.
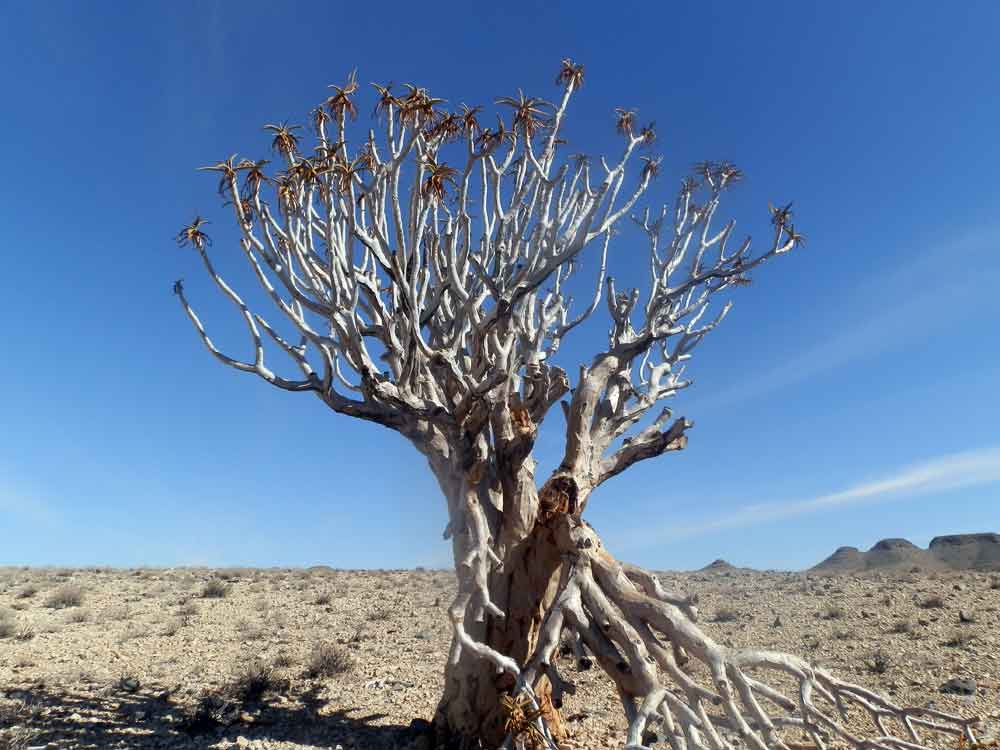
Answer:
[{"left": 174, "top": 60, "right": 973, "bottom": 750}]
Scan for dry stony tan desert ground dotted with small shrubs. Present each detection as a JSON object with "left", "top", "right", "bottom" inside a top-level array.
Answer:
[{"left": 0, "top": 567, "right": 1000, "bottom": 750}]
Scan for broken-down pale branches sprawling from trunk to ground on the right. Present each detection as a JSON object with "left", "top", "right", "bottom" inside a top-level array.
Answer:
[{"left": 522, "top": 516, "right": 978, "bottom": 750}]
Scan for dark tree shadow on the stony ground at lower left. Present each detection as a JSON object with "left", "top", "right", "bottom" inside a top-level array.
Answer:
[{"left": 0, "top": 687, "right": 427, "bottom": 750}]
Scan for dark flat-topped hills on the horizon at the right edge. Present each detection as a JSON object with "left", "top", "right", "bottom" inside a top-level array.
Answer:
[{"left": 812, "top": 534, "right": 1000, "bottom": 573}]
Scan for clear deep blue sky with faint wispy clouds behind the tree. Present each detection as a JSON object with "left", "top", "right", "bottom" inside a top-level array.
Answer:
[{"left": 0, "top": 1, "right": 1000, "bottom": 568}]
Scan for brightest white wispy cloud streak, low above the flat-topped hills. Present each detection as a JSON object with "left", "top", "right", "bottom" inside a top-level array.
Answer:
[{"left": 650, "top": 445, "right": 1000, "bottom": 542}]
